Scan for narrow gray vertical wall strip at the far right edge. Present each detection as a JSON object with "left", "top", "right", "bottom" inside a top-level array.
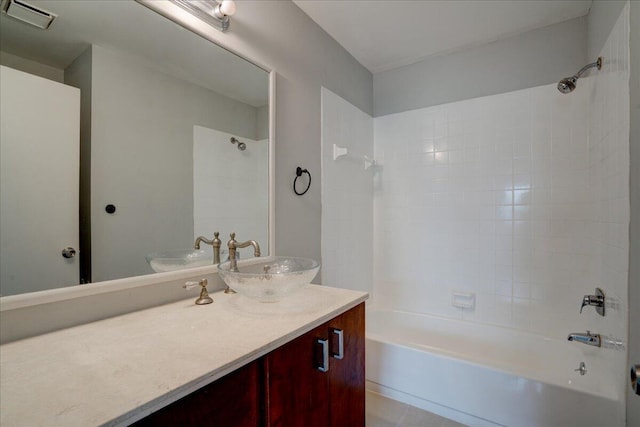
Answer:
[{"left": 628, "top": 1, "right": 640, "bottom": 426}]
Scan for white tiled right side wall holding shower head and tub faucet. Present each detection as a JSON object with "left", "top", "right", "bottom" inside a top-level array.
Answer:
[{"left": 588, "top": 3, "right": 638, "bottom": 416}]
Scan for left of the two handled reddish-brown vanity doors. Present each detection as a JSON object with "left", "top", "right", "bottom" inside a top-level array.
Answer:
[{"left": 264, "top": 324, "right": 329, "bottom": 427}]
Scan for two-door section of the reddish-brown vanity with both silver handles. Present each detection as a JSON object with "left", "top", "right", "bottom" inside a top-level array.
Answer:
[{"left": 264, "top": 303, "right": 365, "bottom": 427}]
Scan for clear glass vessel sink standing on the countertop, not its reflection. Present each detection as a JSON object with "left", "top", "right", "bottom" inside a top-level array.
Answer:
[{"left": 218, "top": 256, "right": 320, "bottom": 302}]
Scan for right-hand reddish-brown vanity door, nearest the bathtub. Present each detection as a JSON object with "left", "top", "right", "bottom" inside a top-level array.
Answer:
[{"left": 327, "top": 303, "right": 365, "bottom": 427}]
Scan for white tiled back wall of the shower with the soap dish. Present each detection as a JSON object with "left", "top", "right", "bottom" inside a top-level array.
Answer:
[{"left": 374, "top": 85, "right": 595, "bottom": 337}]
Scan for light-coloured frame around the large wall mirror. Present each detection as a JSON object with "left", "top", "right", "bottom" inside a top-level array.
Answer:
[{"left": 0, "top": 0, "right": 276, "bottom": 312}]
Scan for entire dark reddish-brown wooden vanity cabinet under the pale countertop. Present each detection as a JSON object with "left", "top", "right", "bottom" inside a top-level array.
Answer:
[{"left": 135, "top": 303, "right": 365, "bottom": 427}]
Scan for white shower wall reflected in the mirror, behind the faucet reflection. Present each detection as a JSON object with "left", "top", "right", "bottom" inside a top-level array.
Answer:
[{"left": 193, "top": 126, "right": 269, "bottom": 261}]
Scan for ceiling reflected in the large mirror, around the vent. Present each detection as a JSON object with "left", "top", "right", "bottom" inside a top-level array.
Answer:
[{"left": 0, "top": 0, "right": 269, "bottom": 107}]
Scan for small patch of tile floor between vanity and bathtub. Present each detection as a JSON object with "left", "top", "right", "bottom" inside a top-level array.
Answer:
[{"left": 367, "top": 391, "right": 464, "bottom": 427}]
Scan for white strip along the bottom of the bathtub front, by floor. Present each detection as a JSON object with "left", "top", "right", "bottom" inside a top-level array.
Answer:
[{"left": 366, "top": 380, "right": 505, "bottom": 427}]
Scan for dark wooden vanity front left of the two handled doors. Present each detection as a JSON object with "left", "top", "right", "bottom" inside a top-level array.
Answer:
[{"left": 134, "top": 361, "right": 262, "bottom": 427}]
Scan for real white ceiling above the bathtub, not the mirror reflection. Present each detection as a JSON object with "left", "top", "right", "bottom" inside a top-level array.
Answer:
[{"left": 293, "top": 0, "right": 592, "bottom": 73}]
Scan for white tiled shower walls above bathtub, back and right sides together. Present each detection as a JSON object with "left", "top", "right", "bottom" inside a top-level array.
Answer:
[{"left": 373, "top": 0, "right": 629, "bottom": 339}]
